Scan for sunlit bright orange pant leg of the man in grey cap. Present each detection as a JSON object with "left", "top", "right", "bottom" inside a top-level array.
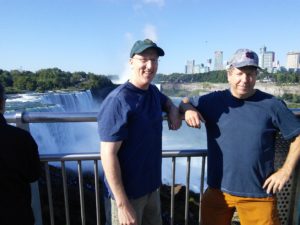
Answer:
[{"left": 236, "top": 197, "right": 280, "bottom": 225}]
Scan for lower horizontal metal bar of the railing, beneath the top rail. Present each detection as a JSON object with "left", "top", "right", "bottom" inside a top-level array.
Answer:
[{"left": 40, "top": 149, "right": 207, "bottom": 162}]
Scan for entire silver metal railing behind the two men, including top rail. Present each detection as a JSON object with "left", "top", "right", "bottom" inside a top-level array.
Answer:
[{"left": 5, "top": 112, "right": 300, "bottom": 225}]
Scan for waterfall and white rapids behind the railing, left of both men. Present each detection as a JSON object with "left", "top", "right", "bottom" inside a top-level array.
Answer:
[{"left": 7, "top": 91, "right": 99, "bottom": 154}]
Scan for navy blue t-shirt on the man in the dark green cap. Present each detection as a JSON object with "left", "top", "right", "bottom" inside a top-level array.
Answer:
[{"left": 98, "top": 82, "right": 167, "bottom": 199}]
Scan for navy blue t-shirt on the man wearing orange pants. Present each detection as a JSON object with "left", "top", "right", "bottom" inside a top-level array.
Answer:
[{"left": 191, "top": 90, "right": 300, "bottom": 197}]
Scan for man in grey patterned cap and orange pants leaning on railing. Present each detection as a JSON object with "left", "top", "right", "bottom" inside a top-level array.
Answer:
[{"left": 180, "top": 49, "right": 300, "bottom": 225}]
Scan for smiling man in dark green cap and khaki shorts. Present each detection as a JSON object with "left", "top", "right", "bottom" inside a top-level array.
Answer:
[{"left": 98, "top": 39, "right": 181, "bottom": 225}]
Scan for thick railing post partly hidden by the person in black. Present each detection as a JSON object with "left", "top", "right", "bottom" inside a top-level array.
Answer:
[{"left": 16, "top": 112, "right": 43, "bottom": 225}]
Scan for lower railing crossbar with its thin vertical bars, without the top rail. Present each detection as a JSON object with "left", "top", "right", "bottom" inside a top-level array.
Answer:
[{"left": 41, "top": 150, "right": 206, "bottom": 225}]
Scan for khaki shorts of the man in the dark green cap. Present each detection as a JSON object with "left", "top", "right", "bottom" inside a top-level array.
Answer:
[{"left": 105, "top": 189, "right": 162, "bottom": 225}]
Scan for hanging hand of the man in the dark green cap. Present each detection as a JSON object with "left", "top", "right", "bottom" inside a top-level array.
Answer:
[{"left": 118, "top": 202, "right": 138, "bottom": 225}]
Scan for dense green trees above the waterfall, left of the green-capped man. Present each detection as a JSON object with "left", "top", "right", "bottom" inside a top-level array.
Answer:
[{"left": 0, "top": 68, "right": 113, "bottom": 93}]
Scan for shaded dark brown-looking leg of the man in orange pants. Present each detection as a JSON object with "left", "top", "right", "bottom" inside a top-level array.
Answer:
[{"left": 201, "top": 188, "right": 235, "bottom": 225}]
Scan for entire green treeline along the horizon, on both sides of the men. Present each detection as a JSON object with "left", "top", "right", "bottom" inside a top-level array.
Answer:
[{"left": 0, "top": 68, "right": 300, "bottom": 93}]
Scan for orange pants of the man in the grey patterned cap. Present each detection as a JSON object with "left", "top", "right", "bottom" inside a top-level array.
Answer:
[{"left": 201, "top": 188, "right": 280, "bottom": 225}]
